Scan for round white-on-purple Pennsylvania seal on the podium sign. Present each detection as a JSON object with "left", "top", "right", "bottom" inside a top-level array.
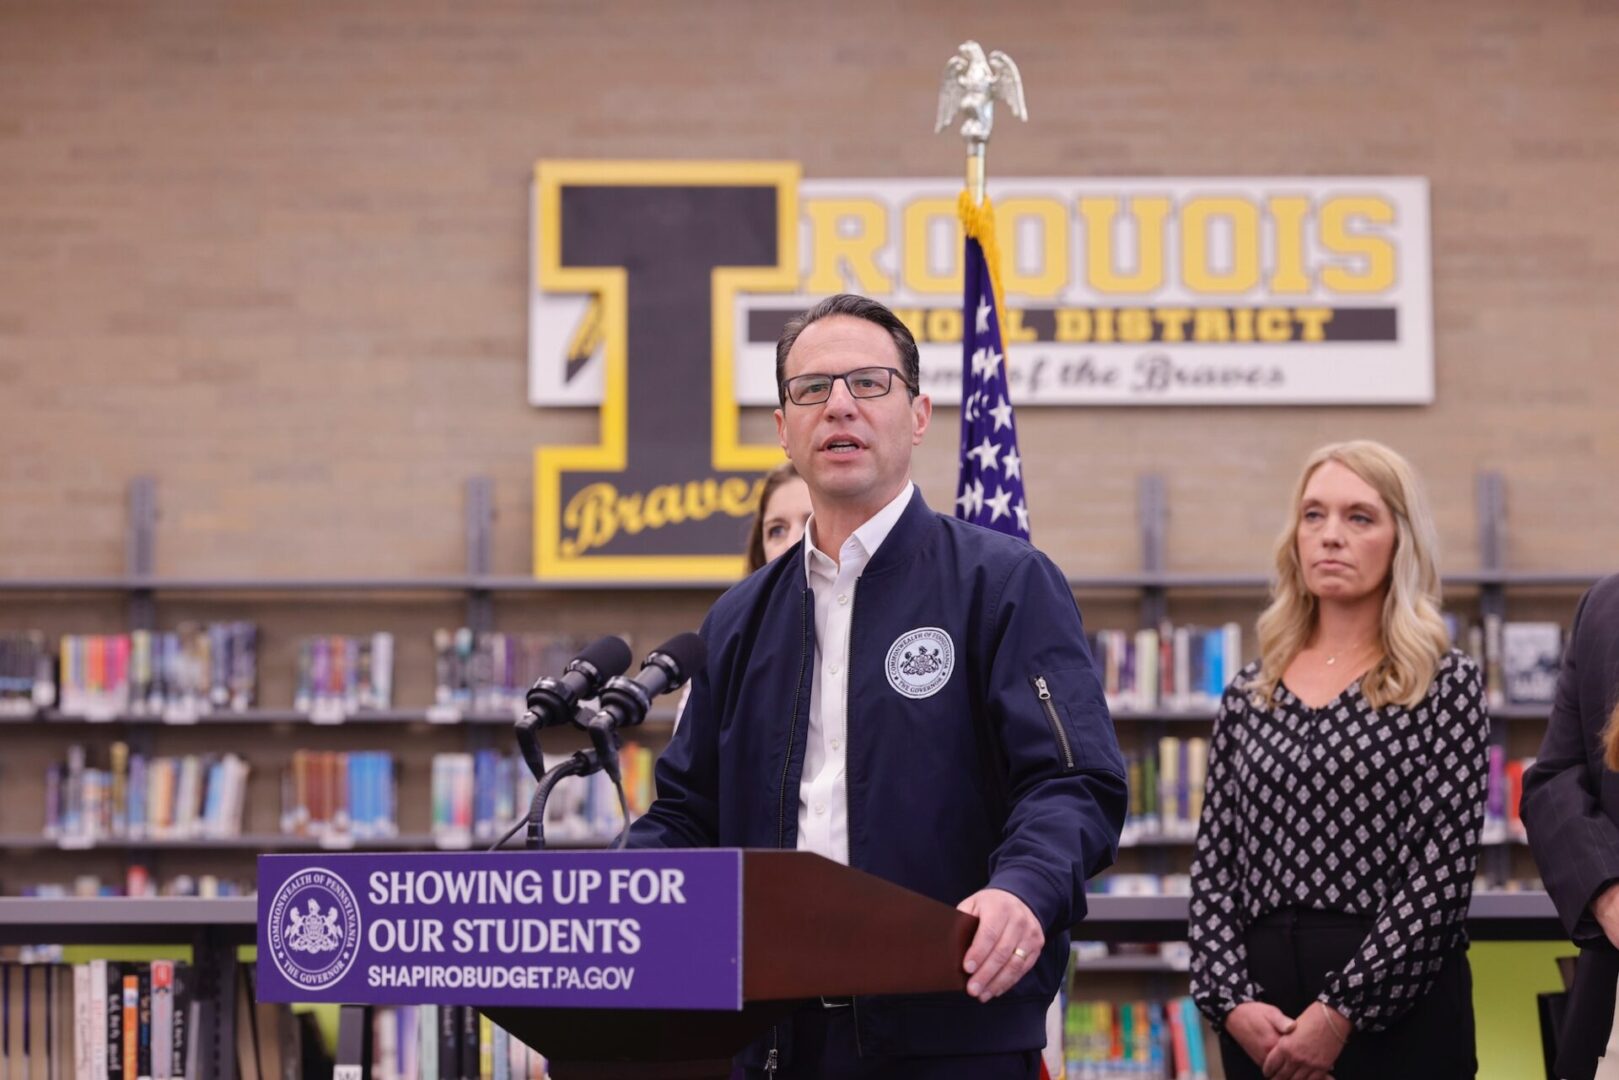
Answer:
[{"left": 264, "top": 866, "right": 359, "bottom": 989}]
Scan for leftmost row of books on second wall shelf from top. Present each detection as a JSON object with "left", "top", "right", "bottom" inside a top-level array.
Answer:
[{"left": 45, "top": 742, "right": 248, "bottom": 845}]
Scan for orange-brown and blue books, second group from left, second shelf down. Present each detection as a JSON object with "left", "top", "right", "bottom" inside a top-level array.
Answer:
[{"left": 280, "top": 750, "right": 398, "bottom": 840}]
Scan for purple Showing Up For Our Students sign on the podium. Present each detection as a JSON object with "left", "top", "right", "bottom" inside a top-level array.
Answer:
[{"left": 257, "top": 850, "right": 742, "bottom": 1009}]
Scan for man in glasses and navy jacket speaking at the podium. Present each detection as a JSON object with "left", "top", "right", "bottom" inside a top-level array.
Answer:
[{"left": 630, "top": 295, "right": 1125, "bottom": 1080}]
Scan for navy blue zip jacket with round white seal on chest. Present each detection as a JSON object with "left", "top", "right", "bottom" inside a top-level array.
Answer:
[{"left": 630, "top": 492, "right": 1127, "bottom": 1057}]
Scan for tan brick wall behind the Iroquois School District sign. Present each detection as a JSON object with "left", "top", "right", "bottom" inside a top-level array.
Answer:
[{"left": 0, "top": 0, "right": 1619, "bottom": 576}]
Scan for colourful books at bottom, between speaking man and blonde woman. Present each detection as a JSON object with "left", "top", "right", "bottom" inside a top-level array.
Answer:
[{"left": 1062, "top": 997, "right": 1209, "bottom": 1080}]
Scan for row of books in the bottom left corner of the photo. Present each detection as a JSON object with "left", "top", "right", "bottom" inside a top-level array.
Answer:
[{"left": 0, "top": 960, "right": 199, "bottom": 1080}]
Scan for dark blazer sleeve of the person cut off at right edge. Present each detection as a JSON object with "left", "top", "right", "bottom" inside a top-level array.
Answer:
[{"left": 1519, "top": 576, "right": 1619, "bottom": 944}]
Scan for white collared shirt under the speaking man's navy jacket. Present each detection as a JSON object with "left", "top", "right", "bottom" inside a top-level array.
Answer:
[{"left": 798, "top": 481, "right": 916, "bottom": 866}]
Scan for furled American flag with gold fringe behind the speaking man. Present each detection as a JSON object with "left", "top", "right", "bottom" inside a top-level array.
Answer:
[{"left": 955, "top": 194, "right": 1028, "bottom": 539}]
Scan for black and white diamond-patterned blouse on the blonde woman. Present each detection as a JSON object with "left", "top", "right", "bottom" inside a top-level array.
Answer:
[{"left": 1188, "top": 649, "right": 1489, "bottom": 1031}]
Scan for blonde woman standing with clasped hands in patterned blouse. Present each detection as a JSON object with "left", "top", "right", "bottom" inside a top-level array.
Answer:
[{"left": 1190, "top": 440, "right": 1489, "bottom": 1080}]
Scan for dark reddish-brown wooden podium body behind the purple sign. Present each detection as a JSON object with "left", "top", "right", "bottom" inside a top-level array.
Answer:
[{"left": 482, "top": 850, "right": 978, "bottom": 1080}]
